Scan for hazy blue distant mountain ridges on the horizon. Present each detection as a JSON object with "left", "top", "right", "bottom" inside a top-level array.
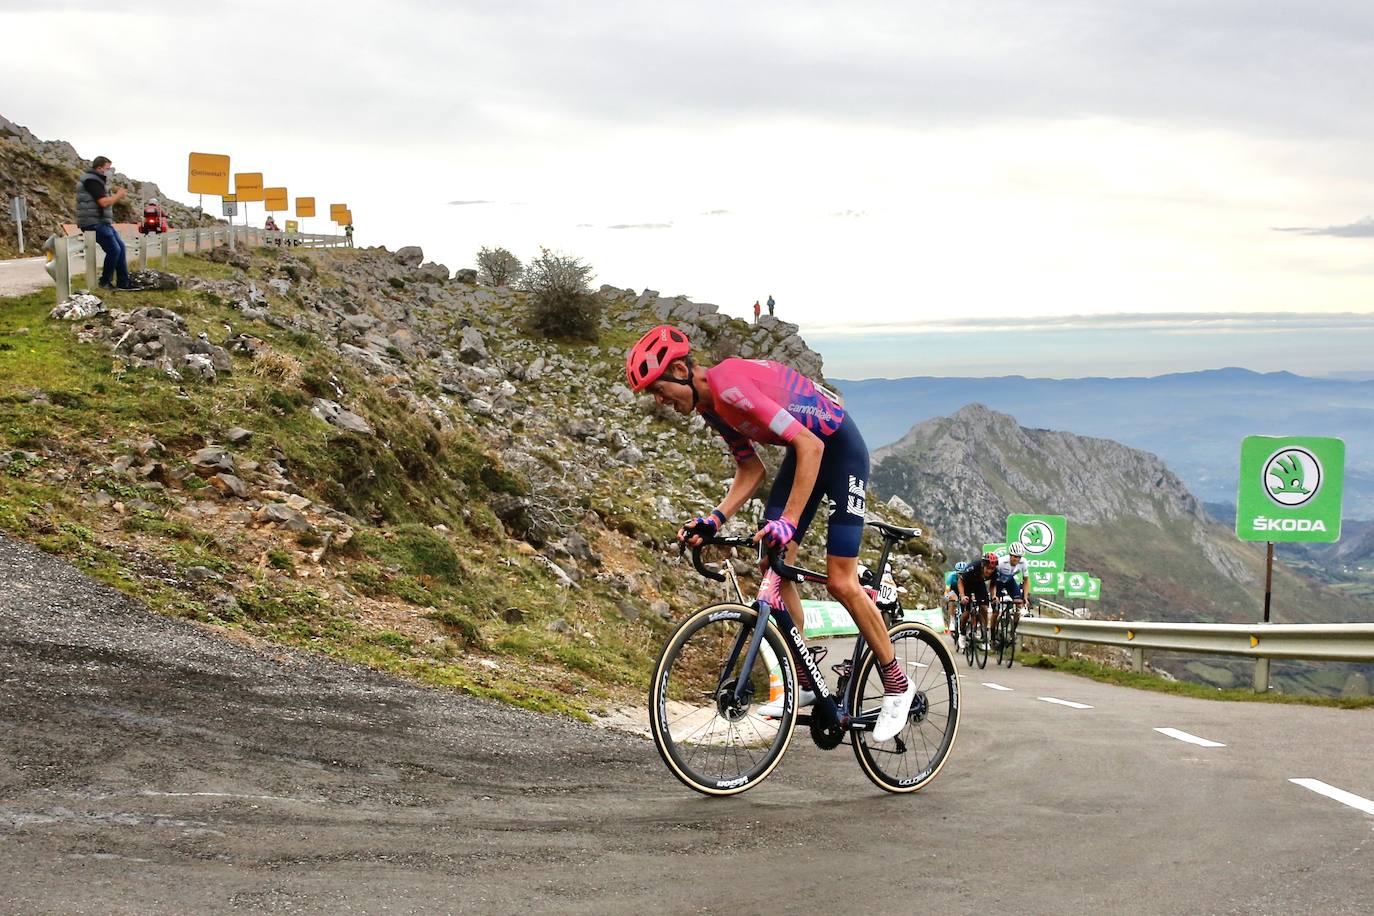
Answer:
[{"left": 831, "top": 368, "right": 1374, "bottom": 519}]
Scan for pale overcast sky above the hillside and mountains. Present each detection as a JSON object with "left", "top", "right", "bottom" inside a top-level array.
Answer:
[{"left": 0, "top": 0, "right": 1374, "bottom": 378}]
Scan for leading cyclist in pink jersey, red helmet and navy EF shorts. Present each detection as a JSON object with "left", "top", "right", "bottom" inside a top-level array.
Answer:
[{"left": 625, "top": 324, "right": 916, "bottom": 742}]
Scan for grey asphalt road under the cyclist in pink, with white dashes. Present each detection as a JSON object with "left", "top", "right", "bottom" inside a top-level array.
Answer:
[{"left": 0, "top": 538, "right": 1374, "bottom": 913}]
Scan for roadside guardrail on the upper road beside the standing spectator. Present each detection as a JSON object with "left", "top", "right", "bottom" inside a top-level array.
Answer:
[{"left": 44, "top": 225, "right": 349, "bottom": 302}]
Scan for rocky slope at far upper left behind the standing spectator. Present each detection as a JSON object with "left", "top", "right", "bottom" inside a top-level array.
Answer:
[{"left": 0, "top": 115, "right": 218, "bottom": 258}]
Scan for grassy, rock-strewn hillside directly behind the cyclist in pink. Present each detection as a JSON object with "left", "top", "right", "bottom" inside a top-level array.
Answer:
[{"left": 0, "top": 249, "right": 943, "bottom": 715}]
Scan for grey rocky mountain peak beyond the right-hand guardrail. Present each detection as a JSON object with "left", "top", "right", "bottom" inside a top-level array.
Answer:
[{"left": 872, "top": 404, "right": 1371, "bottom": 631}]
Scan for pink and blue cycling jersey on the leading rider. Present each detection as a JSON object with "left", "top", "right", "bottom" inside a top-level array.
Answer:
[{"left": 702, "top": 358, "right": 845, "bottom": 461}]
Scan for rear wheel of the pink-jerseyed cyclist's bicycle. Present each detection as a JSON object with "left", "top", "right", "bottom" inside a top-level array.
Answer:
[{"left": 853, "top": 623, "right": 959, "bottom": 792}]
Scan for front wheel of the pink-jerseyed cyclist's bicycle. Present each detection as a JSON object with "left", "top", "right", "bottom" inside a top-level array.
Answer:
[{"left": 649, "top": 604, "right": 797, "bottom": 795}]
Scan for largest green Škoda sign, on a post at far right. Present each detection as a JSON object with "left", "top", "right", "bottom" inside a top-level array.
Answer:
[{"left": 1235, "top": 435, "right": 1345, "bottom": 541}]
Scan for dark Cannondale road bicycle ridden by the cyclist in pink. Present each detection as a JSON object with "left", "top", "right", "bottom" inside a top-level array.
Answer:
[{"left": 649, "top": 522, "right": 959, "bottom": 795}]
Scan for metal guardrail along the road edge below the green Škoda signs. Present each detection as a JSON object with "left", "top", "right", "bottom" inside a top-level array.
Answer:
[{"left": 1018, "top": 617, "right": 1374, "bottom": 694}]
